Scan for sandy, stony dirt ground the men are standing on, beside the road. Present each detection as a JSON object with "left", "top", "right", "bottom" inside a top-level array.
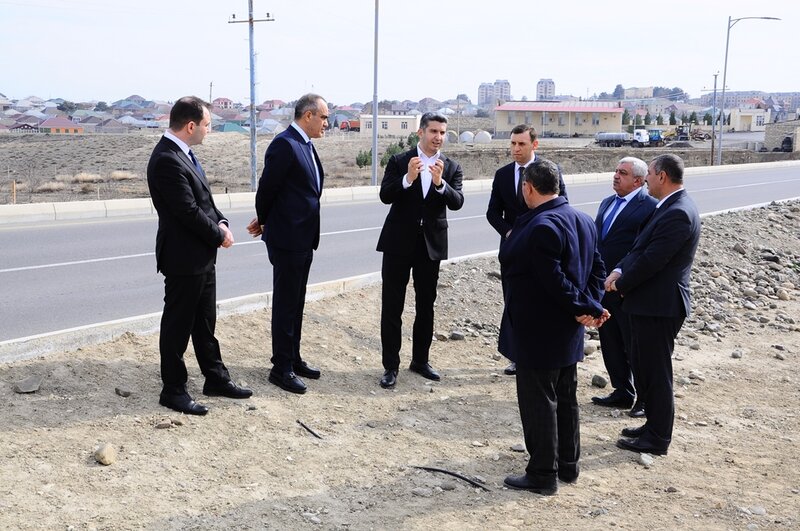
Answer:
[{"left": 0, "top": 203, "right": 800, "bottom": 530}]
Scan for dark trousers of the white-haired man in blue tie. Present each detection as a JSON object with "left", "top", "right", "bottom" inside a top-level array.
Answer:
[{"left": 599, "top": 292, "right": 641, "bottom": 399}]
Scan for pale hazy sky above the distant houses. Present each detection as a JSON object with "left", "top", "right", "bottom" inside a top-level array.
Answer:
[{"left": 0, "top": 0, "right": 800, "bottom": 105}]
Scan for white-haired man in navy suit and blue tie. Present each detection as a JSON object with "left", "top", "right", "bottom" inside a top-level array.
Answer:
[{"left": 592, "top": 157, "right": 656, "bottom": 417}]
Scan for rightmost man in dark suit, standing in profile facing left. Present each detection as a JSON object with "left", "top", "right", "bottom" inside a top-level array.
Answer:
[{"left": 605, "top": 155, "right": 700, "bottom": 455}]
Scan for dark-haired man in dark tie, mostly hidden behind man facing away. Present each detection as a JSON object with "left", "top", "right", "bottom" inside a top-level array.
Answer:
[{"left": 486, "top": 124, "right": 567, "bottom": 375}]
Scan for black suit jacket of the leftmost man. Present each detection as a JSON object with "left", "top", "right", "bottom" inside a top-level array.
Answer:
[{"left": 147, "top": 137, "right": 227, "bottom": 275}]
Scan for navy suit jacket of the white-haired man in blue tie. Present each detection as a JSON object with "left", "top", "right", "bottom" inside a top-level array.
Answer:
[{"left": 594, "top": 187, "right": 658, "bottom": 276}]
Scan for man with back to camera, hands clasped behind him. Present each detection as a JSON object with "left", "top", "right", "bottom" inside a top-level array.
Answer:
[{"left": 499, "top": 159, "right": 608, "bottom": 495}]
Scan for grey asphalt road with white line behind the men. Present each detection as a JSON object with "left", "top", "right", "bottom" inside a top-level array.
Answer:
[{"left": 0, "top": 166, "right": 800, "bottom": 341}]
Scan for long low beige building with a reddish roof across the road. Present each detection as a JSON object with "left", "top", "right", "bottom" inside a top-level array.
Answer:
[{"left": 494, "top": 101, "right": 624, "bottom": 138}]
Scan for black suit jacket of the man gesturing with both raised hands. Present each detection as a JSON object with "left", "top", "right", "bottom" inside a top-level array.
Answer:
[{"left": 378, "top": 148, "right": 464, "bottom": 260}]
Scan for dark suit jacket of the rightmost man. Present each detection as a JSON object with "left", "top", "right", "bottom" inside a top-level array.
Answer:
[{"left": 616, "top": 190, "right": 700, "bottom": 318}]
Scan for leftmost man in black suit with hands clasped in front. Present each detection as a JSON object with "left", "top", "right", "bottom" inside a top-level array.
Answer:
[{"left": 147, "top": 96, "right": 252, "bottom": 415}]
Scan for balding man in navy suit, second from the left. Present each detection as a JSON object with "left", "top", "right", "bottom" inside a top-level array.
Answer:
[{"left": 247, "top": 94, "right": 328, "bottom": 394}]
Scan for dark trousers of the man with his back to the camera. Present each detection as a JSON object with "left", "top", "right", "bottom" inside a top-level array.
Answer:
[{"left": 517, "top": 363, "right": 581, "bottom": 488}]
